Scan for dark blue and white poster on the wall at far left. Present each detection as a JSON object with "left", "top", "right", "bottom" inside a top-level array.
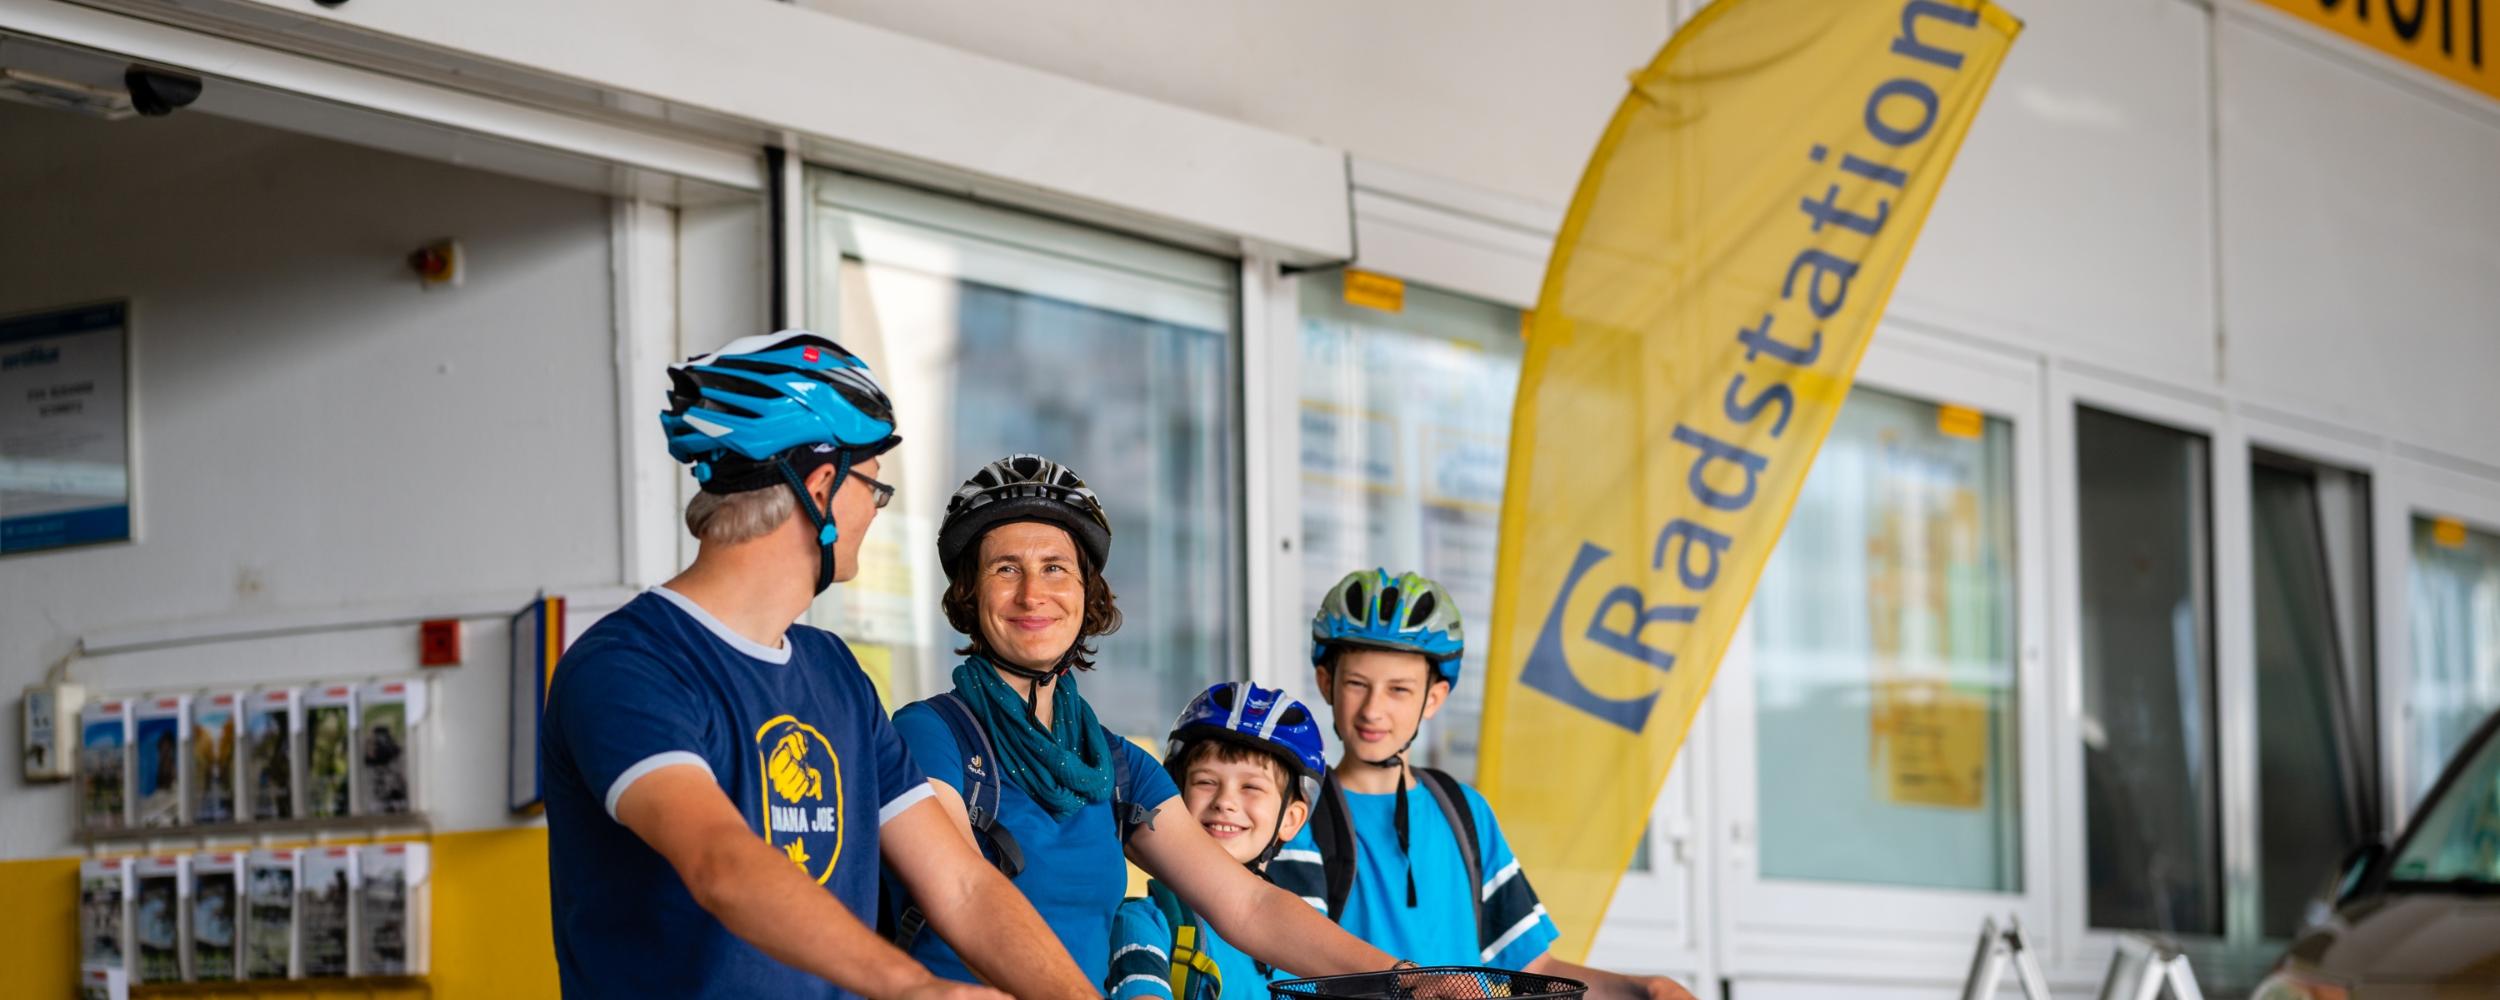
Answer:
[{"left": 0, "top": 303, "right": 130, "bottom": 555}]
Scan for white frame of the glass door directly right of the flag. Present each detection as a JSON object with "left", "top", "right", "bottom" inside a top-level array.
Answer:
[{"left": 1708, "top": 323, "right": 2058, "bottom": 983}]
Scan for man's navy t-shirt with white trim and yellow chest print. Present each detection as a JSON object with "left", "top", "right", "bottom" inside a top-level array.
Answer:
[{"left": 540, "top": 588, "right": 933, "bottom": 998}]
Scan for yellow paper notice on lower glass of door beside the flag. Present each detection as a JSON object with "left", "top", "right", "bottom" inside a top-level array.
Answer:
[{"left": 1873, "top": 683, "right": 1990, "bottom": 810}]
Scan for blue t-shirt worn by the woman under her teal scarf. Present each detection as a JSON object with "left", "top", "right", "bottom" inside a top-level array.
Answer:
[{"left": 895, "top": 703, "right": 1180, "bottom": 983}]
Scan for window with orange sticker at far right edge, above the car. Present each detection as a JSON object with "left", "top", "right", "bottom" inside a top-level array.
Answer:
[{"left": 2405, "top": 518, "right": 2500, "bottom": 803}]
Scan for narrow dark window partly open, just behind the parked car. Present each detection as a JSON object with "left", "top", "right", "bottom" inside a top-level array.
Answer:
[{"left": 2250, "top": 455, "right": 2380, "bottom": 938}]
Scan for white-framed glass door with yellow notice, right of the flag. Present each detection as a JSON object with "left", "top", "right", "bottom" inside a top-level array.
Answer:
[{"left": 1710, "top": 330, "right": 2045, "bottom": 978}]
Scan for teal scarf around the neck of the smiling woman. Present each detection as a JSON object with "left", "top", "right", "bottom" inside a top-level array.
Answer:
[{"left": 955, "top": 658, "right": 1113, "bottom": 820}]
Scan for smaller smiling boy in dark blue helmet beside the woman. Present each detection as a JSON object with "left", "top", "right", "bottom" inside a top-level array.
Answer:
[{"left": 1103, "top": 680, "right": 1328, "bottom": 1000}]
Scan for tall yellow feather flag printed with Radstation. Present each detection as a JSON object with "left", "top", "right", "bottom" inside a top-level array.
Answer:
[{"left": 1480, "top": 0, "right": 2023, "bottom": 960}]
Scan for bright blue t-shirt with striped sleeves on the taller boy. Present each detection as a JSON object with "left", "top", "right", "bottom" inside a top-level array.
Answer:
[{"left": 1270, "top": 785, "right": 1560, "bottom": 970}]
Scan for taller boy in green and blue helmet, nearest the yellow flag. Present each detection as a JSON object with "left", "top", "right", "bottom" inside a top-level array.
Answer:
[{"left": 1268, "top": 570, "right": 1693, "bottom": 1000}]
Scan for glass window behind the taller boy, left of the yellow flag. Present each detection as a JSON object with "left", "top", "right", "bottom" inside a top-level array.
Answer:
[{"left": 1300, "top": 273, "right": 1520, "bottom": 780}]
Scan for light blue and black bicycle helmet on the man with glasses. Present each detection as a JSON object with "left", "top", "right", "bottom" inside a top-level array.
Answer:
[{"left": 660, "top": 330, "right": 903, "bottom": 593}]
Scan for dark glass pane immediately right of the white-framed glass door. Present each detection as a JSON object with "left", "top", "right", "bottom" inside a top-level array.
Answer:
[{"left": 2075, "top": 408, "right": 2223, "bottom": 935}]
